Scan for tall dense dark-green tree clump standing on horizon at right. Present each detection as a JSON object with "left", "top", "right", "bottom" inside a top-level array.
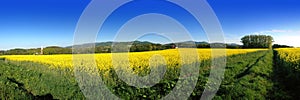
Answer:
[{"left": 241, "top": 35, "right": 273, "bottom": 48}]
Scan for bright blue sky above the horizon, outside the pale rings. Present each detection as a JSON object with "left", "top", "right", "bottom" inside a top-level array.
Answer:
[{"left": 0, "top": 0, "right": 300, "bottom": 50}]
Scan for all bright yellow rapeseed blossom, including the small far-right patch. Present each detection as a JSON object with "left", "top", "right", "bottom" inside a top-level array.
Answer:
[{"left": 3, "top": 49, "right": 264, "bottom": 72}]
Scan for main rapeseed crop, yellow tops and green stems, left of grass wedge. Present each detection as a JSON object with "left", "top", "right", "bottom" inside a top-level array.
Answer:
[{"left": 0, "top": 49, "right": 263, "bottom": 99}]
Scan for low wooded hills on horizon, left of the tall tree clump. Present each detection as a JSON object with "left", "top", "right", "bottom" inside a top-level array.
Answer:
[{"left": 0, "top": 41, "right": 258, "bottom": 55}]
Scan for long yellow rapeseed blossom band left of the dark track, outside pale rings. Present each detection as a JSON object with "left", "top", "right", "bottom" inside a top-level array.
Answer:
[{"left": 3, "top": 49, "right": 267, "bottom": 69}]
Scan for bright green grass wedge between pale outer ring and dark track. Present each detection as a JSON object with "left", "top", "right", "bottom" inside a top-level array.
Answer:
[{"left": 215, "top": 50, "right": 278, "bottom": 99}]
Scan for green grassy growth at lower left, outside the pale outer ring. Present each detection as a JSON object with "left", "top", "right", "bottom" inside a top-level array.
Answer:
[{"left": 0, "top": 61, "right": 84, "bottom": 100}]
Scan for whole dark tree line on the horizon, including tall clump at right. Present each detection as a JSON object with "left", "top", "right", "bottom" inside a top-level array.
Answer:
[{"left": 0, "top": 35, "right": 291, "bottom": 55}]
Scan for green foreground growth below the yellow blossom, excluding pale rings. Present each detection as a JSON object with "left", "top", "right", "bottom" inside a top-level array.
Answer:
[{"left": 0, "top": 50, "right": 300, "bottom": 100}]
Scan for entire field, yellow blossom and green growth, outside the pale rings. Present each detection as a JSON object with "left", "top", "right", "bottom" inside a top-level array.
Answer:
[{"left": 0, "top": 49, "right": 300, "bottom": 99}]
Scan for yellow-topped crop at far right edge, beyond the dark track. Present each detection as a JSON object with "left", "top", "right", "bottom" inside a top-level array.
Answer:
[{"left": 275, "top": 48, "right": 300, "bottom": 99}]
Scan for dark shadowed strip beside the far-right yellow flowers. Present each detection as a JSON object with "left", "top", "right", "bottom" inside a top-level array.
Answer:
[{"left": 269, "top": 50, "right": 300, "bottom": 100}]
